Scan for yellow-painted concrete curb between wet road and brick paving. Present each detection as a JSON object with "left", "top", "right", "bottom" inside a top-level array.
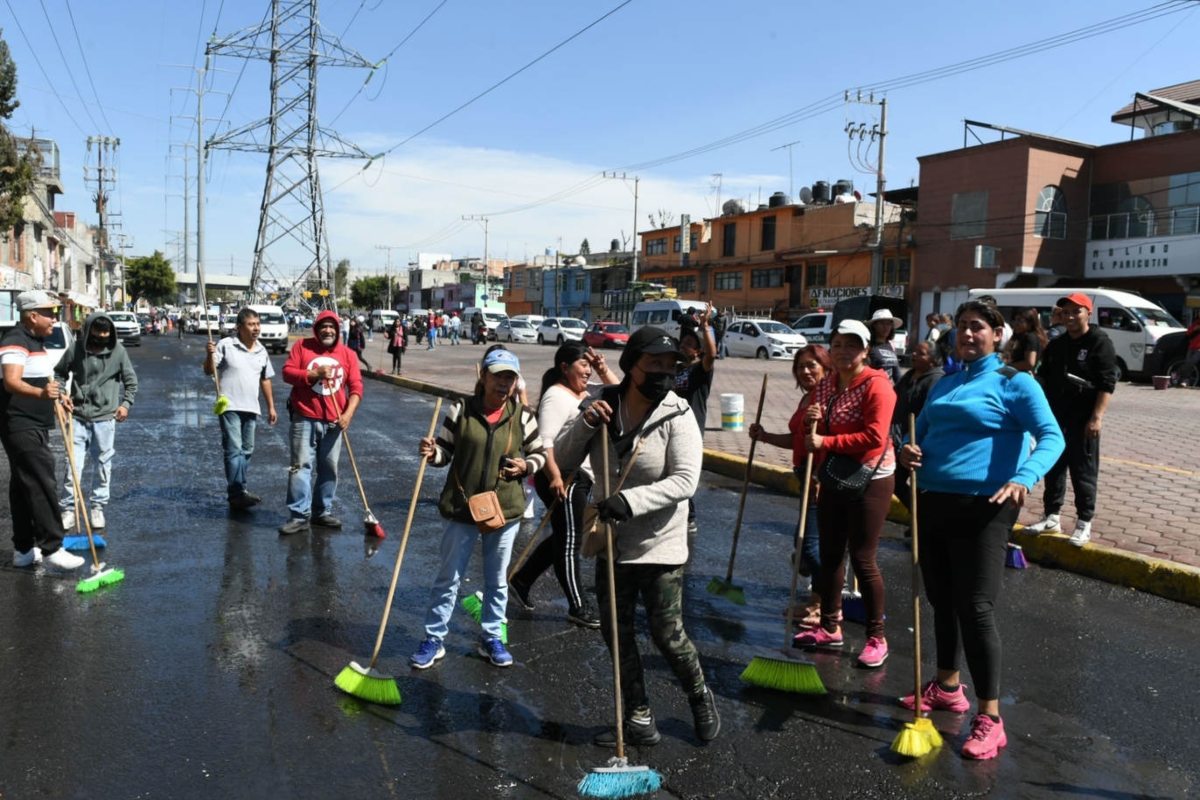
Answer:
[{"left": 364, "top": 373, "right": 1200, "bottom": 606}]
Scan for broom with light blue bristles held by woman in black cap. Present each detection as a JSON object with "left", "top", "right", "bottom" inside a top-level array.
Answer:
[{"left": 576, "top": 425, "right": 662, "bottom": 798}]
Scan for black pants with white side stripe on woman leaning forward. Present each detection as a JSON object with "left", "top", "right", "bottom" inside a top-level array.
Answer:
[{"left": 512, "top": 471, "right": 592, "bottom": 612}]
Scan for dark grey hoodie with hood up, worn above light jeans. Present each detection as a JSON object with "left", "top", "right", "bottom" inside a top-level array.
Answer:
[{"left": 54, "top": 311, "right": 138, "bottom": 422}]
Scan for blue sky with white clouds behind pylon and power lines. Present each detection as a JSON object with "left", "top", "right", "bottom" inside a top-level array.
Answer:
[{"left": 0, "top": 0, "right": 1200, "bottom": 284}]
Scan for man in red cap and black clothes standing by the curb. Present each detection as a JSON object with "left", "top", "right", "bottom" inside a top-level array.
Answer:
[{"left": 1027, "top": 291, "right": 1121, "bottom": 547}]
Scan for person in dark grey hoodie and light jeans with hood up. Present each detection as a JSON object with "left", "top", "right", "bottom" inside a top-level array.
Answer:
[{"left": 54, "top": 311, "right": 138, "bottom": 530}]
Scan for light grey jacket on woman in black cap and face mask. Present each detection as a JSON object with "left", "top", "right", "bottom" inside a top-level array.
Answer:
[{"left": 554, "top": 386, "right": 704, "bottom": 566}]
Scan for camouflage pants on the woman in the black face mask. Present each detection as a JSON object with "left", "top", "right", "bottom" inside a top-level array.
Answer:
[{"left": 596, "top": 559, "right": 704, "bottom": 717}]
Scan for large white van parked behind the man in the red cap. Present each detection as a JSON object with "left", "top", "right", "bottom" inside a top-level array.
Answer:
[{"left": 967, "top": 287, "right": 1184, "bottom": 380}]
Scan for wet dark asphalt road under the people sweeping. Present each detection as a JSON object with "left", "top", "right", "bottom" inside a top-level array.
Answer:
[{"left": 0, "top": 336, "right": 1200, "bottom": 799}]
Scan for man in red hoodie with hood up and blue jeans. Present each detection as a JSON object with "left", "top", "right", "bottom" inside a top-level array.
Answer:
[{"left": 280, "top": 311, "right": 362, "bottom": 535}]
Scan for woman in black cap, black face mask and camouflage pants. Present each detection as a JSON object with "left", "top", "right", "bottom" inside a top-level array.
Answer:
[{"left": 554, "top": 327, "right": 721, "bottom": 747}]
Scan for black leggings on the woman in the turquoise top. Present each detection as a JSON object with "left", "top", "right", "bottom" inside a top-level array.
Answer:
[{"left": 917, "top": 492, "right": 1018, "bottom": 700}]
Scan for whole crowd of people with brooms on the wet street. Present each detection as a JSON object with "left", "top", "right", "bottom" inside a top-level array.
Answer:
[{"left": 0, "top": 291, "right": 1117, "bottom": 759}]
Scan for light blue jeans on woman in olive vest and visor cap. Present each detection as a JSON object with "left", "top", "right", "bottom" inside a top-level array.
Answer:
[{"left": 425, "top": 519, "right": 521, "bottom": 642}]
